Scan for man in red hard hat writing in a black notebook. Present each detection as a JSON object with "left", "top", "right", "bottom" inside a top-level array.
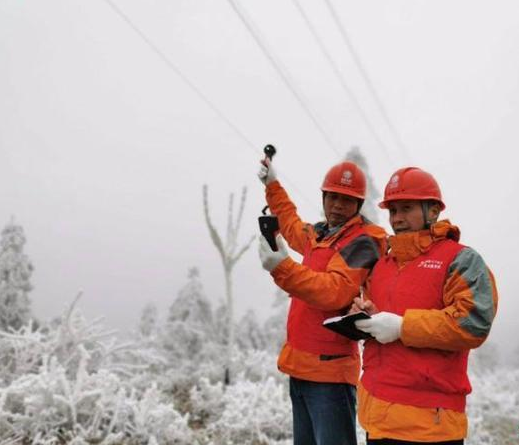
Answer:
[{"left": 352, "top": 167, "right": 497, "bottom": 445}]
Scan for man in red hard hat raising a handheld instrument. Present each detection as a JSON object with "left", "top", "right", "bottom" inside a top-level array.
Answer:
[{"left": 258, "top": 160, "right": 386, "bottom": 445}]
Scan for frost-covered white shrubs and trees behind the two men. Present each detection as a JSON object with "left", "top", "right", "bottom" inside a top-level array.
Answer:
[{"left": 0, "top": 224, "right": 519, "bottom": 445}]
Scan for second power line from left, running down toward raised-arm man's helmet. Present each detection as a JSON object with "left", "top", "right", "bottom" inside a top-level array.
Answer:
[{"left": 228, "top": 0, "right": 342, "bottom": 156}]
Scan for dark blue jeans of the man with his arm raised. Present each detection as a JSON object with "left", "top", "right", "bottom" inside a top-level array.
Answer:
[{"left": 290, "top": 377, "right": 357, "bottom": 445}]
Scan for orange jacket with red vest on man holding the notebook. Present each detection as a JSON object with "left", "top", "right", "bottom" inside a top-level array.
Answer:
[{"left": 358, "top": 220, "right": 498, "bottom": 442}]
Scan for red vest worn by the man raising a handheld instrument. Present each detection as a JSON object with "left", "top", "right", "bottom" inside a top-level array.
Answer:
[{"left": 287, "top": 226, "right": 366, "bottom": 355}]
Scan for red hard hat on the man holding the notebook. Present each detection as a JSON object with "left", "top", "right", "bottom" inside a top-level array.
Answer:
[{"left": 378, "top": 167, "right": 445, "bottom": 210}]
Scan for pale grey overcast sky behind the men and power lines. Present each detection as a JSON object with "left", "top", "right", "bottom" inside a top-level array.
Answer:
[{"left": 0, "top": 0, "right": 519, "bottom": 358}]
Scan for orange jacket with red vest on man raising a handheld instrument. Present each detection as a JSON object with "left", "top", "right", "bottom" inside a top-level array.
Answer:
[{"left": 266, "top": 181, "right": 386, "bottom": 385}]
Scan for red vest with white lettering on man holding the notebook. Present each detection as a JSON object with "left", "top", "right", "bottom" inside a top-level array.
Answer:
[{"left": 362, "top": 239, "right": 471, "bottom": 412}]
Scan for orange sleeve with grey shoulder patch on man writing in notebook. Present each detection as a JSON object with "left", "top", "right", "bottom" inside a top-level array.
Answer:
[{"left": 401, "top": 247, "right": 498, "bottom": 351}]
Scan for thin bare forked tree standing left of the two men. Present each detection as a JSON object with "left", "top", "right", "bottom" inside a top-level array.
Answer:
[{"left": 203, "top": 185, "right": 254, "bottom": 384}]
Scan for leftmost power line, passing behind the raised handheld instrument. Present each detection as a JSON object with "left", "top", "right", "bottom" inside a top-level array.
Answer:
[{"left": 101, "top": 0, "right": 315, "bottom": 212}]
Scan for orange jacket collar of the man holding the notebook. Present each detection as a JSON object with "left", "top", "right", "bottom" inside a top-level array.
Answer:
[{"left": 388, "top": 220, "right": 460, "bottom": 264}]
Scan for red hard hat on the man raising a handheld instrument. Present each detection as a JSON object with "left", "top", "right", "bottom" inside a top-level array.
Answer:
[{"left": 321, "top": 161, "right": 366, "bottom": 199}]
